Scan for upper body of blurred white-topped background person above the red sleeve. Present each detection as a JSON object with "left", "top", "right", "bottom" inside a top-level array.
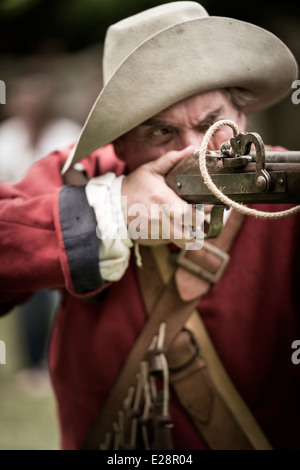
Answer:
[{"left": 0, "top": 73, "right": 81, "bottom": 182}]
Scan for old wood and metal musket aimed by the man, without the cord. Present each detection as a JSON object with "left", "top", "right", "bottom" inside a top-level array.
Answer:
[{"left": 166, "top": 132, "right": 300, "bottom": 237}]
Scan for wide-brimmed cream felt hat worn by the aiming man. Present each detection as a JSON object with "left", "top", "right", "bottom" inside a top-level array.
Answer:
[{"left": 63, "top": 2, "right": 298, "bottom": 172}]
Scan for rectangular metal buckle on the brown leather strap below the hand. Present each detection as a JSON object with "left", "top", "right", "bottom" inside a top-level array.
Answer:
[{"left": 176, "top": 241, "right": 230, "bottom": 284}]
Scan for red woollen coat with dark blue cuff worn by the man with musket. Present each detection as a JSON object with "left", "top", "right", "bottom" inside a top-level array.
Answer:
[{"left": 0, "top": 146, "right": 300, "bottom": 450}]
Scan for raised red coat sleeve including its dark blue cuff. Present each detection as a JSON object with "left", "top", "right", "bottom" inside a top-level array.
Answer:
[{"left": 0, "top": 149, "right": 104, "bottom": 314}]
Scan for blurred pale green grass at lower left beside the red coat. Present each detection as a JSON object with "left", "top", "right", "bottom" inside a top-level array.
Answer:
[{"left": 0, "top": 315, "right": 60, "bottom": 450}]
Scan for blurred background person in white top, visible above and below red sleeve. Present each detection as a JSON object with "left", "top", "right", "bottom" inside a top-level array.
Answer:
[{"left": 0, "top": 72, "right": 81, "bottom": 396}]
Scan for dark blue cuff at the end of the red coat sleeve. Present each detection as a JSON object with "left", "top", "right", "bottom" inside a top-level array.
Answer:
[{"left": 59, "top": 185, "right": 104, "bottom": 294}]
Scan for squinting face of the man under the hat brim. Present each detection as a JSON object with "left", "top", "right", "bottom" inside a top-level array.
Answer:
[{"left": 115, "top": 90, "right": 246, "bottom": 171}]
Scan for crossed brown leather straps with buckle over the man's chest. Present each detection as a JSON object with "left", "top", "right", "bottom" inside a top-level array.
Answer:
[{"left": 83, "top": 212, "right": 271, "bottom": 450}]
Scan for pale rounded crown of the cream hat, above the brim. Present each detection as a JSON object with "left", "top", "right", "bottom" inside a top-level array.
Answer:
[{"left": 103, "top": 2, "right": 208, "bottom": 85}]
